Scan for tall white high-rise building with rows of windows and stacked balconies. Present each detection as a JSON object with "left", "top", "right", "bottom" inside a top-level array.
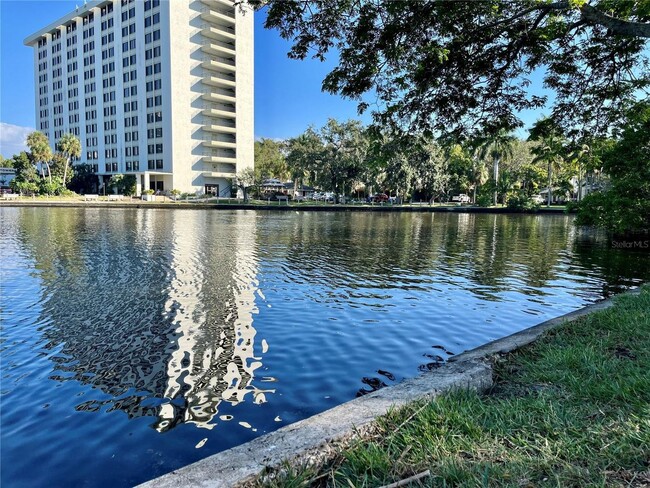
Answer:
[{"left": 24, "top": 0, "right": 254, "bottom": 196}]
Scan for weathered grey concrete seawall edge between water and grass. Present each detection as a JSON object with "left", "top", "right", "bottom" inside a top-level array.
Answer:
[{"left": 140, "top": 290, "right": 639, "bottom": 488}]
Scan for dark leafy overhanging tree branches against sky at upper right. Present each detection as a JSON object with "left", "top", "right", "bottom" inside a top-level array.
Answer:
[{"left": 250, "top": 0, "right": 650, "bottom": 136}]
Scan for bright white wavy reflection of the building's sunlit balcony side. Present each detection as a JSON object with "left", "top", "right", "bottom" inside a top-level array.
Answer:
[{"left": 155, "top": 212, "right": 274, "bottom": 431}]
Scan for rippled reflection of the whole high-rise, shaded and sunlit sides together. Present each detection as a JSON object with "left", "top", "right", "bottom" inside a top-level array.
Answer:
[{"left": 20, "top": 209, "right": 264, "bottom": 430}]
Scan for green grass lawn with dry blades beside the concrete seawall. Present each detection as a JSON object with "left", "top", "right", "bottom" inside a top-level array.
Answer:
[{"left": 259, "top": 287, "right": 650, "bottom": 487}]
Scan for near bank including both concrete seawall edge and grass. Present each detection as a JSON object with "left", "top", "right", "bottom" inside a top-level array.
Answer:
[{"left": 142, "top": 286, "right": 650, "bottom": 488}]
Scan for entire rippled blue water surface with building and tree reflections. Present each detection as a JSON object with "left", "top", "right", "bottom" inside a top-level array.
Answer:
[{"left": 0, "top": 207, "right": 650, "bottom": 487}]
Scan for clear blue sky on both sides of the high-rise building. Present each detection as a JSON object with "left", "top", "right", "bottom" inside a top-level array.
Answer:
[{"left": 0, "top": 0, "right": 539, "bottom": 157}]
